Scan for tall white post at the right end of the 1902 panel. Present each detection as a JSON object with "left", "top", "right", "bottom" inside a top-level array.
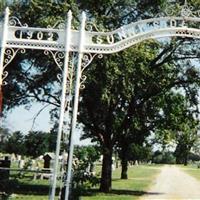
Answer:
[{"left": 49, "top": 11, "right": 72, "bottom": 200}]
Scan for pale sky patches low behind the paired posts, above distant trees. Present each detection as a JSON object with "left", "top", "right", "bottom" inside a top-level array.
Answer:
[{"left": 4, "top": 103, "right": 90, "bottom": 145}]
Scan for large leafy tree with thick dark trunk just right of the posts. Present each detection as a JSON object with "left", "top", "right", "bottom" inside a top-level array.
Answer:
[{"left": 80, "top": 36, "right": 199, "bottom": 188}]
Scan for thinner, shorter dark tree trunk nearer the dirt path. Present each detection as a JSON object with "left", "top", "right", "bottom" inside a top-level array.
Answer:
[{"left": 121, "top": 145, "right": 128, "bottom": 179}]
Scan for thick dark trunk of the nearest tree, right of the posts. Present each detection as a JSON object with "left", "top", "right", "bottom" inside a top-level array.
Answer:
[{"left": 100, "top": 142, "right": 112, "bottom": 193}]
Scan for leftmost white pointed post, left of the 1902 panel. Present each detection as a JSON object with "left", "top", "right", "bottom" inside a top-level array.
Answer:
[{"left": 0, "top": 7, "right": 10, "bottom": 106}]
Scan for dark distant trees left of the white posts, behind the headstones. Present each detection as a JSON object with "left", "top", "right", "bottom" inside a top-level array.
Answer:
[{"left": 0, "top": 129, "right": 56, "bottom": 158}]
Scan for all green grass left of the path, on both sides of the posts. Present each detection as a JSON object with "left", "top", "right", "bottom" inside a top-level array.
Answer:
[{"left": 1, "top": 165, "right": 160, "bottom": 200}]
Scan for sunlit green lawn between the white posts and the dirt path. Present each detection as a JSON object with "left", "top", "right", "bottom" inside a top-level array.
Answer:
[{"left": 81, "top": 165, "right": 160, "bottom": 200}]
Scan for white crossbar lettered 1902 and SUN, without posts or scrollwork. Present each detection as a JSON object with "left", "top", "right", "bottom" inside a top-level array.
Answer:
[{"left": 3, "top": 17, "right": 200, "bottom": 54}]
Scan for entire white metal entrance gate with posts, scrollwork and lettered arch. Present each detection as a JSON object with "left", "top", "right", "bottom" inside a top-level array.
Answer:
[{"left": 0, "top": 1, "right": 200, "bottom": 200}]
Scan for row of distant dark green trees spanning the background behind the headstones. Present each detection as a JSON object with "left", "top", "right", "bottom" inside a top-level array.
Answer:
[{"left": 0, "top": 128, "right": 200, "bottom": 164}]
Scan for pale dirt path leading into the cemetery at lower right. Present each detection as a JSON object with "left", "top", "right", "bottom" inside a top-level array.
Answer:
[{"left": 142, "top": 166, "right": 200, "bottom": 200}]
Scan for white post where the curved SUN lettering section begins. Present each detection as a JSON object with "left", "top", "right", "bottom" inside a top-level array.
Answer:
[{"left": 65, "top": 12, "right": 86, "bottom": 200}]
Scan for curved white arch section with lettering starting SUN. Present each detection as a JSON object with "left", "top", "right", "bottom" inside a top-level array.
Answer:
[{"left": 81, "top": 17, "right": 200, "bottom": 54}]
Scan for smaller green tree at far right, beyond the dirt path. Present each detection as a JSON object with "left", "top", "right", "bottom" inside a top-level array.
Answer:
[{"left": 154, "top": 91, "right": 199, "bottom": 164}]
